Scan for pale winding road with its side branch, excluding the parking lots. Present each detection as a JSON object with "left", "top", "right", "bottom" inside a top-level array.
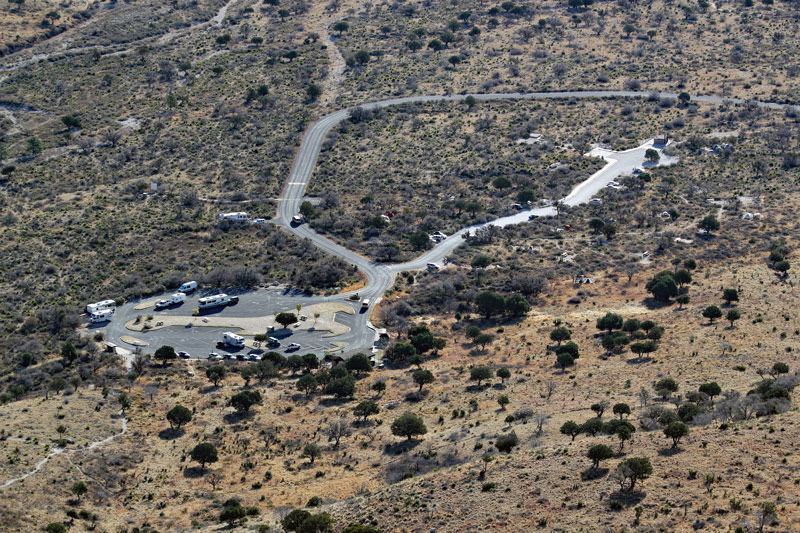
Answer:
[{"left": 273, "top": 91, "right": 800, "bottom": 344}]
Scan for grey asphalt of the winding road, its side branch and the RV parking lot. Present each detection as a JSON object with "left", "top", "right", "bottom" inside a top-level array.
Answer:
[{"left": 103, "top": 91, "right": 800, "bottom": 358}]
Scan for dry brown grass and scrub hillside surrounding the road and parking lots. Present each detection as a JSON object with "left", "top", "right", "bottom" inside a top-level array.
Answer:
[{"left": 0, "top": 0, "right": 800, "bottom": 531}]
